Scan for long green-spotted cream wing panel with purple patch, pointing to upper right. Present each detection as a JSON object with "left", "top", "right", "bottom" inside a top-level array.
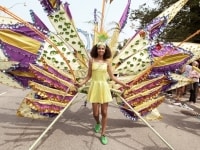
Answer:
[{"left": 112, "top": 0, "right": 188, "bottom": 74}]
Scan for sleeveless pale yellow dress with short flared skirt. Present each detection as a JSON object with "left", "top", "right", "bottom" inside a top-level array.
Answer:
[{"left": 87, "top": 61, "right": 112, "bottom": 104}]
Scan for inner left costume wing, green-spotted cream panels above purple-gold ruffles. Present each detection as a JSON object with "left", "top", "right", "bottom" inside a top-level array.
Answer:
[{"left": 18, "top": 1, "right": 88, "bottom": 118}]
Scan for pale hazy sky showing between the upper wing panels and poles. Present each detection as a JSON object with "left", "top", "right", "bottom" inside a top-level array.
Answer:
[{"left": 0, "top": 0, "right": 154, "bottom": 42}]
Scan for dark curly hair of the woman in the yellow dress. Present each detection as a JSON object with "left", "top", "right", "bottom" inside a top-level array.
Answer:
[{"left": 90, "top": 44, "right": 112, "bottom": 60}]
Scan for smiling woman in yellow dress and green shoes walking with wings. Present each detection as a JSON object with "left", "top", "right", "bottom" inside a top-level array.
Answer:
[{"left": 79, "top": 42, "right": 129, "bottom": 145}]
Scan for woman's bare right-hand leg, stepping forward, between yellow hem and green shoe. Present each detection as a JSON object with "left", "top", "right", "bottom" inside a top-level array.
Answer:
[{"left": 101, "top": 103, "right": 108, "bottom": 135}]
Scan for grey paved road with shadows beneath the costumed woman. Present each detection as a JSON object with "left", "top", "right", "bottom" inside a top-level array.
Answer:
[{"left": 0, "top": 85, "right": 200, "bottom": 150}]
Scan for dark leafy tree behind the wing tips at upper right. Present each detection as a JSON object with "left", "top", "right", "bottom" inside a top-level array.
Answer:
[{"left": 130, "top": 0, "right": 200, "bottom": 43}]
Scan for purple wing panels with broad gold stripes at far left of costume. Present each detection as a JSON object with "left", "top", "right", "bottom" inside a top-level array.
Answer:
[{"left": 0, "top": 10, "right": 48, "bottom": 88}]
